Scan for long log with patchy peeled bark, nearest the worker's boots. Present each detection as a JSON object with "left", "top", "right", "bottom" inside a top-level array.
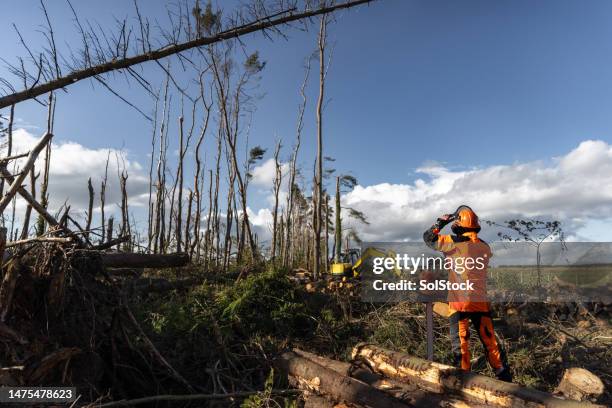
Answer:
[{"left": 352, "top": 344, "right": 596, "bottom": 408}]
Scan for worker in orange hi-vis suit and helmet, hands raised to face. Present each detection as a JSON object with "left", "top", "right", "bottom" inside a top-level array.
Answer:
[{"left": 423, "top": 206, "right": 512, "bottom": 382}]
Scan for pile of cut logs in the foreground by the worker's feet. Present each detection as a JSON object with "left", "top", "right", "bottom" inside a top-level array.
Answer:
[{"left": 276, "top": 344, "right": 599, "bottom": 408}]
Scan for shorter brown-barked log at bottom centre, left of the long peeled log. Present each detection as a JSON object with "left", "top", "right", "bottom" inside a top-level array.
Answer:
[{"left": 275, "top": 352, "right": 410, "bottom": 408}]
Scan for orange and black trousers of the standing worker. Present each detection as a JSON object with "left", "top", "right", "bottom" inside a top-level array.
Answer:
[{"left": 450, "top": 312, "right": 508, "bottom": 371}]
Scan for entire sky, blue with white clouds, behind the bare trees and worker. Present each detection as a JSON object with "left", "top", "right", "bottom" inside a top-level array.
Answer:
[{"left": 0, "top": 0, "right": 612, "bottom": 241}]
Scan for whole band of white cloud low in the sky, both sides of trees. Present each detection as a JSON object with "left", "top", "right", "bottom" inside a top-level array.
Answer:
[{"left": 5, "top": 129, "right": 612, "bottom": 243}]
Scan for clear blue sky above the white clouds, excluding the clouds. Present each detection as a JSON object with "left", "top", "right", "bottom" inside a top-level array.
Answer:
[{"left": 0, "top": 0, "right": 612, "bottom": 241}]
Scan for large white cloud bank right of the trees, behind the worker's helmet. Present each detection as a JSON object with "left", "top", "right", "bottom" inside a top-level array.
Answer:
[{"left": 342, "top": 140, "right": 612, "bottom": 241}]
